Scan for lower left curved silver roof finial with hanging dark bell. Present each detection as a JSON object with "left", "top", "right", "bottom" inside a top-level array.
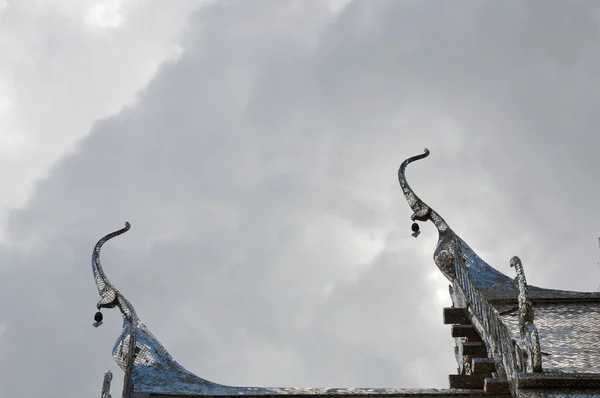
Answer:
[{"left": 92, "top": 222, "right": 137, "bottom": 327}]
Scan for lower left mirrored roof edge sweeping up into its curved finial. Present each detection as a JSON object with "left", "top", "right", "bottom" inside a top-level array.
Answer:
[{"left": 92, "top": 223, "right": 488, "bottom": 398}]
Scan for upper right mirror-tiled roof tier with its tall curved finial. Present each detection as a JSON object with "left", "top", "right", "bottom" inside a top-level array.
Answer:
[{"left": 398, "top": 149, "right": 600, "bottom": 397}]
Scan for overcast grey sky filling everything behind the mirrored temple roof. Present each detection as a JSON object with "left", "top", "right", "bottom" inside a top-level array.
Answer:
[{"left": 0, "top": 0, "right": 600, "bottom": 398}]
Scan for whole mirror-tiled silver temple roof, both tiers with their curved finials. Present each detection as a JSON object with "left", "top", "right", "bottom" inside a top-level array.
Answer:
[{"left": 92, "top": 149, "right": 600, "bottom": 397}]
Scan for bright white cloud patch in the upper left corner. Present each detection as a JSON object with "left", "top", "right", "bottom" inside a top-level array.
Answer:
[{"left": 0, "top": 0, "right": 208, "bottom": 239}]
